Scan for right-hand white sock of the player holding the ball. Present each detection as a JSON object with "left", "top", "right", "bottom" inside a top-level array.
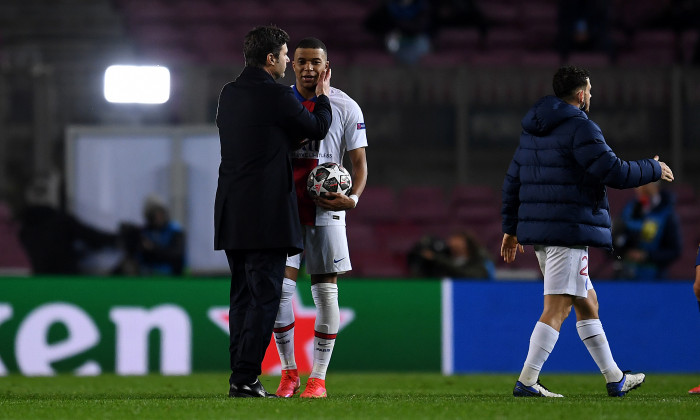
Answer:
[{"left": 309, "top": 283, "right": 340, "bottom": 380}]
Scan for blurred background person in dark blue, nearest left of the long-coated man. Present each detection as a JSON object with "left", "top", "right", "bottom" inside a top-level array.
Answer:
[{"left": 117, "top": 195, "right": 185, "bottom": 276}]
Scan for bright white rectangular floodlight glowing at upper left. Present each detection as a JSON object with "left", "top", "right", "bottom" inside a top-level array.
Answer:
[{"left": 104, "top": 65, "right": 170, "bottom": 104}]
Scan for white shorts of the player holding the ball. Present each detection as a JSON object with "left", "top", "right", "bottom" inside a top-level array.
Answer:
[{"left": 287, "top": 225, "right": 352, "bottom": 274}]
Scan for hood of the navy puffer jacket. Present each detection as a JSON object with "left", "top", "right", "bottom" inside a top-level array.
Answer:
[{"left": 521, "top": 96, "right": 588, "bottom": 136}]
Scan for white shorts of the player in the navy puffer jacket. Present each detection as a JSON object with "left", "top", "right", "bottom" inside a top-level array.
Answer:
[{"left": 535, "top": 245, "right": 593, "bottom": 298}]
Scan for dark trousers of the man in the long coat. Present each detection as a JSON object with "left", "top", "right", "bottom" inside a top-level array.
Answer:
[{"left": 226, "top": 249, "right": 287, "bottom": 384}]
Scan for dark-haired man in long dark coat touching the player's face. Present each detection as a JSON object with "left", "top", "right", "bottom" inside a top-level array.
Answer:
[{"left": 214, "top": 26, "right": 332, "bottom": 397}]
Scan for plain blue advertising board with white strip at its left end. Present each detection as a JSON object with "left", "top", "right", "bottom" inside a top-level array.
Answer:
[{"left": 442, "top": 280, "right": 700, "bottom": 374}]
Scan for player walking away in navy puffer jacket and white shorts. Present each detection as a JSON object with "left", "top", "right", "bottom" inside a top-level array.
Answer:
[{"left": 501, "top": 66, "right": 673, "bottom": 397}]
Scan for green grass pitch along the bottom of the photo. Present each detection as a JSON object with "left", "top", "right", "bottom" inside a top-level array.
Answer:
[{"left": 0, "top": 373, "right": 700, "bottom": 420}]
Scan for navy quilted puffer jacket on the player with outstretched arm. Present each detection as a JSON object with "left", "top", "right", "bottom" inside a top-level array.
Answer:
[{"left": 501, "top": 96, "right": 661, "bottom": 249}]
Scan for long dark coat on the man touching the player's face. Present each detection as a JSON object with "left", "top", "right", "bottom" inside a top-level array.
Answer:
[{"left": 214, "top": 67, "right": 332, "bottom": 255}]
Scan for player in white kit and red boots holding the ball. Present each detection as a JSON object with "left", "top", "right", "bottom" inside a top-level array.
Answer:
[{"left": 274, "top": 38, "right": 367, "bottom": 398}]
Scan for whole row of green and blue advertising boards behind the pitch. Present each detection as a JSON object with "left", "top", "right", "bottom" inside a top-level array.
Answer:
[{"left": 0, "top": 277, "right": 700, "bottom": 375}]
